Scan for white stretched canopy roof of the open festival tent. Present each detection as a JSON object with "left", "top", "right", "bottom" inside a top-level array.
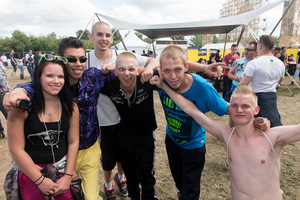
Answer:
[{"left": 96, "top": 0, "right": 283, "bottom": 39}]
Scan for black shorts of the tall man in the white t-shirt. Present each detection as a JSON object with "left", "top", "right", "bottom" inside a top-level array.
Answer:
[{"left": 100, "top": 124, "right": 120, "bottom": 171}]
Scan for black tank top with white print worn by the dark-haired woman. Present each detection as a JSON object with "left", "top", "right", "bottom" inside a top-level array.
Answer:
[{"left": 24, "top": 106, "right": 70, "bottom": 164}]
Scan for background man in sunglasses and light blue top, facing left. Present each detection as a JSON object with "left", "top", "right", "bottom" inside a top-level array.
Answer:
[{"left": 224, "top": 41, "right": 257, "bottom": 102}]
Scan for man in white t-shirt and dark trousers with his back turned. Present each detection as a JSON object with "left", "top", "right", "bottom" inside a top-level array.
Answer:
[{"left": 240, "top": 35, "right": 285, "bottom": 127}]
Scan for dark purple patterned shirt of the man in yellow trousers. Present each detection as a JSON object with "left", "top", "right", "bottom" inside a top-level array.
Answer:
[{"left": 16, "top": 67, "right": 115, "bottom": 150}]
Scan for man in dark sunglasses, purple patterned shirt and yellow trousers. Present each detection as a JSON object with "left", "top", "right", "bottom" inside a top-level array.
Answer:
[{"left": 4, "top": 37, "right": 115, "bottom": 200}]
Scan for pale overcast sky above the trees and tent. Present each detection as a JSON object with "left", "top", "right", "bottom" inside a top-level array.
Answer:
[{"left": 0, "top": 0, "right": 283, "bottom": 38}]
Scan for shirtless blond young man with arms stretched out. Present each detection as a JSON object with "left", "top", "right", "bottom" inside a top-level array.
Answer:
[{"left": 150, "top": 76, "right": 300, "bottom": 200}]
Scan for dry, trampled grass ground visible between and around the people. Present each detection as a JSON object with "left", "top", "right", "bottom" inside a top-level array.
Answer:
[{"left": 0, "top": 69, "right": 300, "bottom": 200}]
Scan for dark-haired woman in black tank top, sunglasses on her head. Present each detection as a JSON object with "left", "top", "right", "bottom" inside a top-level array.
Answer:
[{"left": 7, "top": 55, "right": 79, "bottom": 200}]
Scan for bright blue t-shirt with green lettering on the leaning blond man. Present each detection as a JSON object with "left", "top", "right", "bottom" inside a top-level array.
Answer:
[{"left": 158, "top": 74, "right": 227, "bottom": 149}]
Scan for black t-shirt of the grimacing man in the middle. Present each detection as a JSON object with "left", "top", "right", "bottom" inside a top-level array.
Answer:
[{"left": 101, "top": 76, "right": 157, "bottom": 134}]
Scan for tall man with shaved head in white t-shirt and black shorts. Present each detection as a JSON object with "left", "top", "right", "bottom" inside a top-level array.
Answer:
[{"left": 87, "top": 22, "right": 158, "bottom": 200}]
